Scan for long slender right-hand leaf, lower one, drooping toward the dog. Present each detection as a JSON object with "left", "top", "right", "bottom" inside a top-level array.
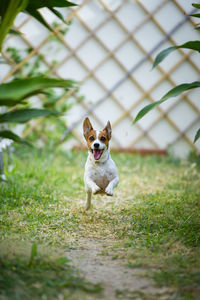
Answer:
[{"left": 133, "top": 81, "right": 200, "bottom": 124}]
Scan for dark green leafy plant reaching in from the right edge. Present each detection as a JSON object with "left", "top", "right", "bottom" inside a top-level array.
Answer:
[{"left": 134, "top": 3, "right": 200, "bottom": 143}]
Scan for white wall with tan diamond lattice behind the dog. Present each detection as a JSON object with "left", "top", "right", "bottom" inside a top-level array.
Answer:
[{"left": 0, "top": 0, "right": 200, "bottom": 157}]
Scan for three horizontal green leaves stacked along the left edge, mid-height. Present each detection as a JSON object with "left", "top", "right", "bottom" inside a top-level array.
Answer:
[{"left": 0, "top": 76, "right": 75, "bottom": 144}]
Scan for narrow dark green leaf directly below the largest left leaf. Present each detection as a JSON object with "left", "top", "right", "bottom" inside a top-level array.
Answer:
[{"left": 0, "top": 108, "right": 58, "bottom": 123}]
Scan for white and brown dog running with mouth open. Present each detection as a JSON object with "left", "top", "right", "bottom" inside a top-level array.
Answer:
[{"left": 83, "top": 118, "right": 119, "bottom": 210}]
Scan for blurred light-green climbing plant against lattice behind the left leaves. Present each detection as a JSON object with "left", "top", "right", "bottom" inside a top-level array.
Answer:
[{"left": 3, "top": 41, "right": 76, "bottom": 145}]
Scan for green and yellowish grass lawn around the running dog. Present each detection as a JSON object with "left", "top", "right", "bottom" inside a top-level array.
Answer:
[{"left": 0, "top": 149, "right": 200, "bottom": 300}]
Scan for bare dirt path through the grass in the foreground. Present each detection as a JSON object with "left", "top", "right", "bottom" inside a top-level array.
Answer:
[{"left": 66, "top": 238, "right": 167, "bottom": 300}]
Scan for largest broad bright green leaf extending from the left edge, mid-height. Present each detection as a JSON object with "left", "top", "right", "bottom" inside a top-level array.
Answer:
[{"left": 0, "top": 76, "right": 75, "bottom": 106}]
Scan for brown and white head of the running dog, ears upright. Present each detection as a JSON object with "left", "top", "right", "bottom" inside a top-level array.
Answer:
[{"left": 83, "top": 118, "right": 112, "bottom": 161}]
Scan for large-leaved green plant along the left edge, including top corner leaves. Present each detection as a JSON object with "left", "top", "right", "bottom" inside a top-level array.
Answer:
[{"left": 0, "top": 0, "right": 75, "bottom": 143}]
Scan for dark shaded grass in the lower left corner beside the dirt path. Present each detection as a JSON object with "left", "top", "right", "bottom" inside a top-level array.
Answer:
[{"left": 0, "top": 244, "right": 102, "bottom": 299}]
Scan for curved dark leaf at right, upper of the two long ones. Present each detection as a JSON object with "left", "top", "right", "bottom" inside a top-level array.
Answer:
[{"left": 153, "top": 41, "right": 200, "bottom": 68}]
